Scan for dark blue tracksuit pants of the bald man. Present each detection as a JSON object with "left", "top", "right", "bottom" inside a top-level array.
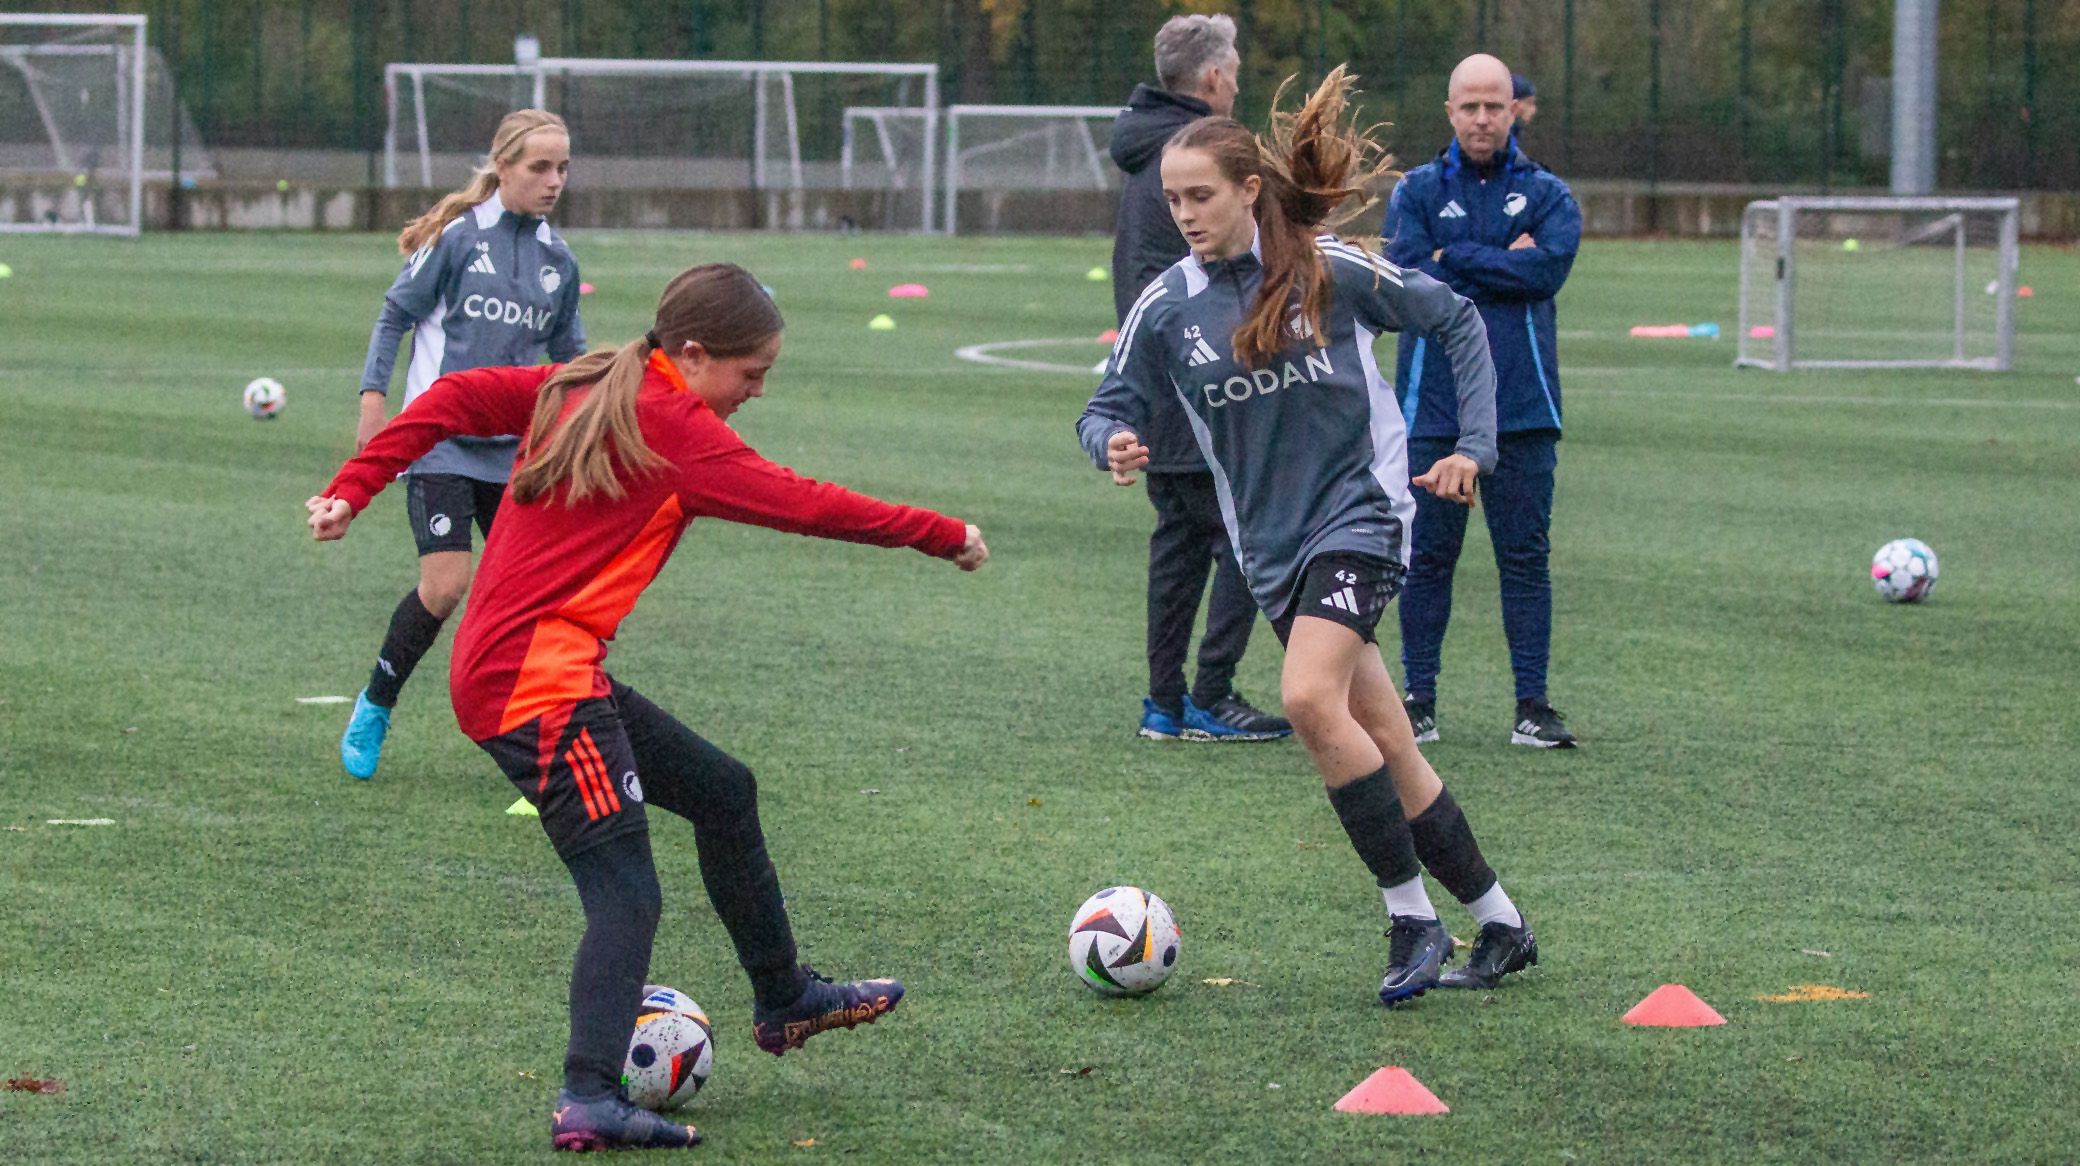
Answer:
[{"left": 1402, "top": 430, "right": 1560, "bottom": 700}]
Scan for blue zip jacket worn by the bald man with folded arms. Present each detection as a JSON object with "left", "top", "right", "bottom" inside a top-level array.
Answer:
[{"left": 1381, "top": 135, "right": 1581, "bottom": 436}]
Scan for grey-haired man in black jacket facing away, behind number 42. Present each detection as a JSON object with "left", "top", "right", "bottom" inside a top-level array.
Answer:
[{"left": 1113, "top": 15, "right": 1292, "bottom": 740}]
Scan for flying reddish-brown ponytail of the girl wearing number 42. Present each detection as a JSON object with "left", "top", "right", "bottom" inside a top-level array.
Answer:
[{"left": 1165, "top": 64, "right": 1392, "bottom": 368}]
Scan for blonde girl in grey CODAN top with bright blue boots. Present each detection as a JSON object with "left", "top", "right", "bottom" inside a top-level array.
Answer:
[{"left": 339, "top": 110, "right": 584, "bottom": 779}]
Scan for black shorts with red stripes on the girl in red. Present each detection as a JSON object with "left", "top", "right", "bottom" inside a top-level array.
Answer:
[{"left": 476, "top": 696, "right": 649, "bottom": 858}]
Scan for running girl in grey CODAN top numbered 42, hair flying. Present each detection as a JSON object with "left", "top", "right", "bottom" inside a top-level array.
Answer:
[{"left": 1077, "top": 69, "right": 1537, "bottom": 1004}]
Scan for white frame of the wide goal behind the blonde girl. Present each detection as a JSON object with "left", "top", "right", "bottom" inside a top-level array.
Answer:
[{"left": 383, "top": 56, "right": 940, "bottom": 231}]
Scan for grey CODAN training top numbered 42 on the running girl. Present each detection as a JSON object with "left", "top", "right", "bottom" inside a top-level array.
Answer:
[{"left": 1075, "top": 235, "right": 1496, "bottom": 617}]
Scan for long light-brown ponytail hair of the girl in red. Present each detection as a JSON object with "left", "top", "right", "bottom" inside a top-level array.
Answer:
[{"left": 512, "top": 264, "right": 784, "bottom": 505}]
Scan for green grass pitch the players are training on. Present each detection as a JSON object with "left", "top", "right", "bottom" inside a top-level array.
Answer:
[{"left": 0, "top": 233, "right": 2080, "bottom": 1164}]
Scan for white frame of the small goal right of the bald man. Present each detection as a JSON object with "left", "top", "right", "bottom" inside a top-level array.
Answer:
[{"left": 1735, "top": 195, "right": 2020, "bottom": 372}]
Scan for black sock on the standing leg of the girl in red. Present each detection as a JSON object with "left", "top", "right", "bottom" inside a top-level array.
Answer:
[{"left": 564, "top": 831, "right": 664, "bottom": 1097}]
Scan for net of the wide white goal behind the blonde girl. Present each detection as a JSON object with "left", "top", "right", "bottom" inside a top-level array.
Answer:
[{"left": 383, "top": 56, "right": 938, "bottom": 229}]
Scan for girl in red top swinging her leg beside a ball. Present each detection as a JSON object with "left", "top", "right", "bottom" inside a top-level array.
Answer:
[{"left": 306, "top": 264, "right": 990, "bottom": 1149}]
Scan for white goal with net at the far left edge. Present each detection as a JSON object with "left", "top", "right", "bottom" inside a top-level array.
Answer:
[{"left": 0, "top": 12, "right": 150, "bottom": 235}]
